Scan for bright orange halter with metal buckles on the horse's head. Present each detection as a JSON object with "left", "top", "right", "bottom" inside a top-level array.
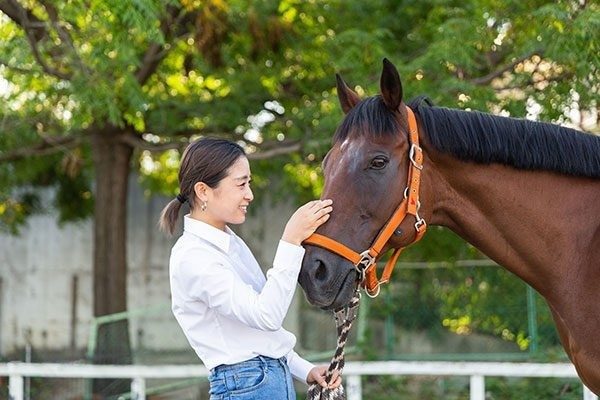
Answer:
[{"left": 304, "top": 107, "right": 427, "bottom": 297}]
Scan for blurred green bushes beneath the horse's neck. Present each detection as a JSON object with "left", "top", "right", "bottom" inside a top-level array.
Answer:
[{"left": 367, "top": 227, "right": 564, "bottom": 360}]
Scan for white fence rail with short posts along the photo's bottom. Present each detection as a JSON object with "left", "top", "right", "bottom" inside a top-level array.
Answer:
[{"left": 0, "top": 361, "right": 598, "bottom": 400}]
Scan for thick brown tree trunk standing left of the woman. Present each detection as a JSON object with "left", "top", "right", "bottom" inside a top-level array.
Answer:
[{"left": 91, "top": 127, "right": 133, "bottom": 397}]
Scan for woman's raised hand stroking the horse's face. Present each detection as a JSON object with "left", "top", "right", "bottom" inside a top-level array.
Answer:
[{"left": 281, "top": 200, "right": 333, "bottom": 246}]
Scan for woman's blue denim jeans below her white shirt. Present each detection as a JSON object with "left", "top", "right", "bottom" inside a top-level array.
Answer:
[{"left": 208, "top": 356, "right": 296, "bottom": 400}]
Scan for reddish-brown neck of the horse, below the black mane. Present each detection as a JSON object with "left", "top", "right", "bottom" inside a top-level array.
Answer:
[{"left": 424, "top": 152, "right": 600, "bottom": 294}]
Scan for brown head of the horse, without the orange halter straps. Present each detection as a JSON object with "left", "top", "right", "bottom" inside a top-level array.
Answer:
[{"left": 299, "top": 60, "right": 426, "bottom": 309}]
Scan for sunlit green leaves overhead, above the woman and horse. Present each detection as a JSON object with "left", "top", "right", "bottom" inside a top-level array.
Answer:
[{"left": 0, "top": 0, "right": 600, "bottom": 225}]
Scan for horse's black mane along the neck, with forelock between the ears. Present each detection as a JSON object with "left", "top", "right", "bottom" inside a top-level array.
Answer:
[{"left": 334, "top": 96, "right": 600, "bottom": 178}]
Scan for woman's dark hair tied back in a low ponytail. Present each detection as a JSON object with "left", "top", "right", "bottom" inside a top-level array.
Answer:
[{"left": 159, "top": 137, "right": 246, "bottom": 234}]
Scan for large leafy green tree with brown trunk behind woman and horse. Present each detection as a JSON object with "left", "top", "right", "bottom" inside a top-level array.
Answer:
[{"left": 0, "top": 0, "right": 600, "bottom": 394}]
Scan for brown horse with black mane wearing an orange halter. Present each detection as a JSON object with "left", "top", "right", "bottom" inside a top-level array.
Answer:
[{"left": 298, "top": 59, "right": 600, "bottom": 394}]
